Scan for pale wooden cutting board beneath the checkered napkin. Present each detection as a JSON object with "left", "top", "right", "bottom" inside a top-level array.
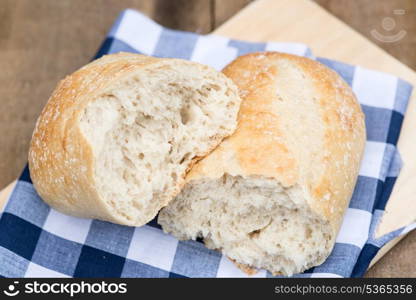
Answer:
[{"left": 0, "top": 0, "right": 416, "bottom": 272}]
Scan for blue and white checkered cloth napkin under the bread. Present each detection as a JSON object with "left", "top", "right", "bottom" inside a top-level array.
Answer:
[{"left": 0, "top": 10, "right": 415, "bottom": 277}]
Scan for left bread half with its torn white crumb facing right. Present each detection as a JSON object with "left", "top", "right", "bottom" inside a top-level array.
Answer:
[{"left": 29, "top": 53, "right": 241, "bottom": 226}]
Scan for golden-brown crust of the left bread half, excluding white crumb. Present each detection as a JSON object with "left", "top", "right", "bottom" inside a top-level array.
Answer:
[{"left": 29, "top": 53, "right": 237, "bottom": 226}]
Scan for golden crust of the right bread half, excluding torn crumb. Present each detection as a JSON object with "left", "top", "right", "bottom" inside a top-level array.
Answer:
[{"left": 187, "top": 52, "right": 365, "bottom": 248}]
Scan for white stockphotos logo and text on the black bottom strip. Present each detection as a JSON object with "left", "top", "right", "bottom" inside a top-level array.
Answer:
[{"left": 3, "top": 280, "right": 127, "bottom": 297}]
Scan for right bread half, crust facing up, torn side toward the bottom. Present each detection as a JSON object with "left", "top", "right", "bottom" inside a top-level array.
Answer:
[{"left": 158, "top": 52, "right": 365, "bottom": 275}]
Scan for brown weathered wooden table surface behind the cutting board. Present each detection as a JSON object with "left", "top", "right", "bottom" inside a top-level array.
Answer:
[{"left": 0, "top": 0, "right": 416, "bottom": 277}]
